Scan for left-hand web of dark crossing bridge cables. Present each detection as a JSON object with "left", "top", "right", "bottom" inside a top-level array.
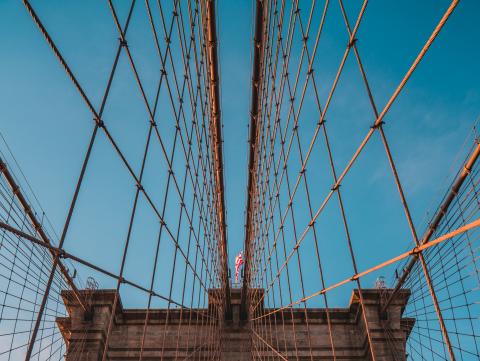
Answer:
[{"left": 0, "top": 0, "right": 229, "bottom": 360}]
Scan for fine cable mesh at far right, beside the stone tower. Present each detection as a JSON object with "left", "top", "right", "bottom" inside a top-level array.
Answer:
[{"left": 398, "top": 143, "right": 480, "bottom": 359}]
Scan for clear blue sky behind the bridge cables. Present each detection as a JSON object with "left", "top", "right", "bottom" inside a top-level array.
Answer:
[{"left": 0, "top": 0, "right": 480, "bottom": 305}]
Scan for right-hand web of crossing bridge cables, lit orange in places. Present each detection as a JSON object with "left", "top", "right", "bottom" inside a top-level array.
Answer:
[{"left": 243, "top": 0, "right": 480, "bottom": 360}]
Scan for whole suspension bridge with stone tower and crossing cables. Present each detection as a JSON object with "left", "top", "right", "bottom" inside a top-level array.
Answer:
[{"left": 0, "top": 0, "right": 480, "bottom": 361}]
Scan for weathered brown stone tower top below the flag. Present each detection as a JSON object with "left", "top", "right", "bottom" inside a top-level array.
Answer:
[{"left": 57, "top": 289, "right": 414, "bottom": 361}]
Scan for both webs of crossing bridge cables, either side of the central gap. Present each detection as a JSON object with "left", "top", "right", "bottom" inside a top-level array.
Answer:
[{"left": 0, "top": 0, "right": 480, "bottom": 361}]
